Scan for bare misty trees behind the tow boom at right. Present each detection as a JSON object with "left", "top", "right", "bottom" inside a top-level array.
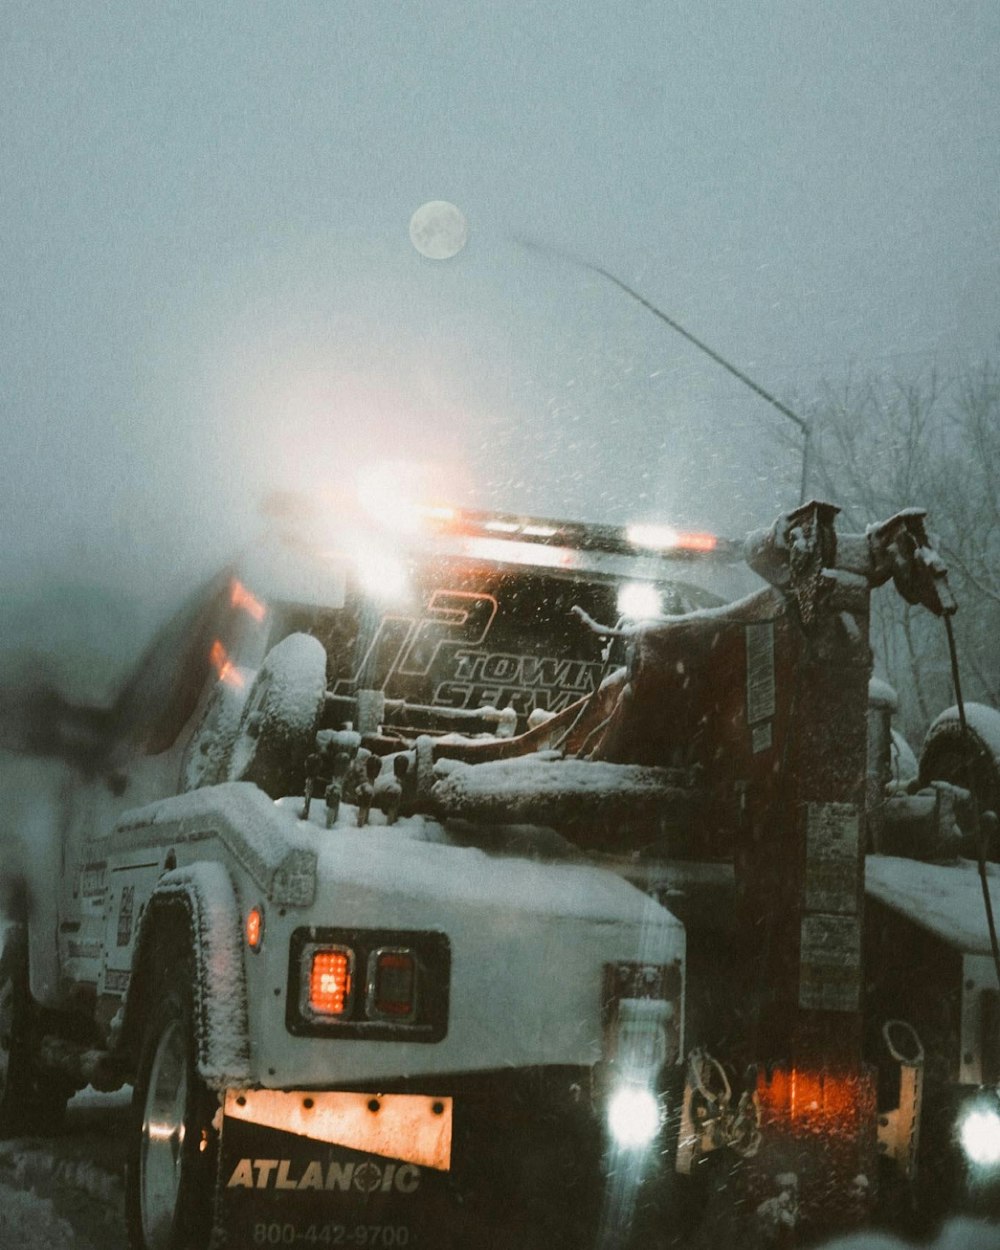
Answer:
[{"left": 780, "top": 361, "right": 1000, "bottom": 741}]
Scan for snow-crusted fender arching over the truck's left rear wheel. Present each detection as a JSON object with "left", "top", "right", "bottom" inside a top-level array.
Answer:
[{"left": 121, "top": 863, "right": 250, "bottom": 1090}]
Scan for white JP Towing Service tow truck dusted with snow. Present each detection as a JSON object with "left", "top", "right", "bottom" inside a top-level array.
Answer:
[{"left": 0, "top": 485, "right": 1000, "bottom": 1250}]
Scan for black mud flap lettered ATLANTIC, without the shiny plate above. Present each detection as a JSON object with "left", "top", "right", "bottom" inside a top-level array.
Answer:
[{"left": 213, "top": 1090, "right": 605, "bottom": 1250}]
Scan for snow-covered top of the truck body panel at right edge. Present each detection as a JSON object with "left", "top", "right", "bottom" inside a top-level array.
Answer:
[{"left": 865, "top": 855, "right": 1000, "bottom": 955}]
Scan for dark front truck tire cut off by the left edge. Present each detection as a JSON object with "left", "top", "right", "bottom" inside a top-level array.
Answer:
[{"left": 0, "top": 924, "right": 71, "bottom": 1138}]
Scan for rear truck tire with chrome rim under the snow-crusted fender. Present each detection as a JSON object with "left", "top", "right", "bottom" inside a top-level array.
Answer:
[{"left": 125, "top": 955, "right": 219, "bottom": 1250}]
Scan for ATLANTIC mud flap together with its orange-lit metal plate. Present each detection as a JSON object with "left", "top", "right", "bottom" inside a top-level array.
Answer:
[{"left": 213, "top": 1081, "right": 610, "bottom": 1250}]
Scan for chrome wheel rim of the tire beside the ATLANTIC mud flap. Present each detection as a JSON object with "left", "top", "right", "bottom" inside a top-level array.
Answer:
[{"left": 139, "top": 1020, "right": 188, "bottom": 1250}]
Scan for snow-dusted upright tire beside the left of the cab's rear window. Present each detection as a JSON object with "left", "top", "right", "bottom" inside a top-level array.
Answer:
[{"left": 229, "top": 634, "right": 326, "bottom": 799}]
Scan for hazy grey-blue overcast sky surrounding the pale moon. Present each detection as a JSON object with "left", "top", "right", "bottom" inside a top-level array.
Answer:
[{"left": 0, "top": 0, "right": 1000, "bottom": 645}]
